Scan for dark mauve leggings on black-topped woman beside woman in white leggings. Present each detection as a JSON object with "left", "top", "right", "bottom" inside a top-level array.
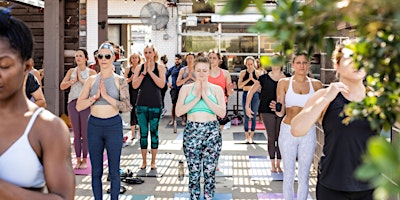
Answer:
[{"left": 260, "top": 113, "right": 282, "bottom": 160}]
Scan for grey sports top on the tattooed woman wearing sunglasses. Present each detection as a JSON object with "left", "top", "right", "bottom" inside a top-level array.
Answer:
[{"left": 90, "top": 74, "right": 119, "bottom": 105}]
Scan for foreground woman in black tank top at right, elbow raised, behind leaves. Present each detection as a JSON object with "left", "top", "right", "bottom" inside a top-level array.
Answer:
[{"left": 291, "top": 45, "right": 376, "bottom": 200}]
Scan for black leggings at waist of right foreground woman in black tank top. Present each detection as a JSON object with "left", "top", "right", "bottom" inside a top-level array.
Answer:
[{"left": 317, "top": 182, "right": 374, "bottom": 200}]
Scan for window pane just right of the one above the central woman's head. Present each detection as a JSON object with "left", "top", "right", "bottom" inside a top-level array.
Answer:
[{"left": 221, "top": 35, "right": 258, "bottom": 53}]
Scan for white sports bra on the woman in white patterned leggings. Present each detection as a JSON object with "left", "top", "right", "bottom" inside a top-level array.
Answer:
[{"left": 285, "top": 76, "right": 315, "bottom": 108}]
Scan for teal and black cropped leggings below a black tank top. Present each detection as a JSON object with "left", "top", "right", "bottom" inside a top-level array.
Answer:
[{"left": 136, "top": 106, "right": 162, "bottom": 149}]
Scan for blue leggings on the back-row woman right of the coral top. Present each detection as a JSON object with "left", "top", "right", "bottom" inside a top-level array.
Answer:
[{"left": 242, "top": 91, "right": 260, "bottom": 132}]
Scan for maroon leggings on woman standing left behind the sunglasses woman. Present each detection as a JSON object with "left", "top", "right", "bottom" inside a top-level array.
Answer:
[{"left": 67, "top": 99, "right": 90, "bottom": 158}]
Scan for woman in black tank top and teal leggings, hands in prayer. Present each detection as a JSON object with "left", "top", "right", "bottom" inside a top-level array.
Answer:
[{"left": 132, "top": 44, "right": 166, "bottom": 170}]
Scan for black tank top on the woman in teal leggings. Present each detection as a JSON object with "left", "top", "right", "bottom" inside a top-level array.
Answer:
[{"left": 136, "top": 63, "right": 162, "bottom": 107}]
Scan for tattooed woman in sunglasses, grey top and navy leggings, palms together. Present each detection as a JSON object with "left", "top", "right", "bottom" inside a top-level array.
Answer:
[{"left": 76, "top": 43, "right": 131, "bottom": 200}]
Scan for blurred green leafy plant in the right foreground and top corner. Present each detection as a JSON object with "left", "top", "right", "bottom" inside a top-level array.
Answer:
[{"left": 223, "top": 0, "right": 400, "bottom": 195}]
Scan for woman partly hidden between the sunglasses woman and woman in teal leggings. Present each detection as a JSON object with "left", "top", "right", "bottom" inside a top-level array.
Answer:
[{"left": 124, "top": 53, "right": 142, "bottom": 140}]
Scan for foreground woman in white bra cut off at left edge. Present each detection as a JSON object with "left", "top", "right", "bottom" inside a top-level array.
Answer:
[{"left": 0, "top": 7, "right": 75, "bottom": 200}]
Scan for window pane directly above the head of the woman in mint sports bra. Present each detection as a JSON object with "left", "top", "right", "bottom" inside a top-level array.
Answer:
[{"left": 182, "top": 36, "right": 218, "bottom": 52}]
